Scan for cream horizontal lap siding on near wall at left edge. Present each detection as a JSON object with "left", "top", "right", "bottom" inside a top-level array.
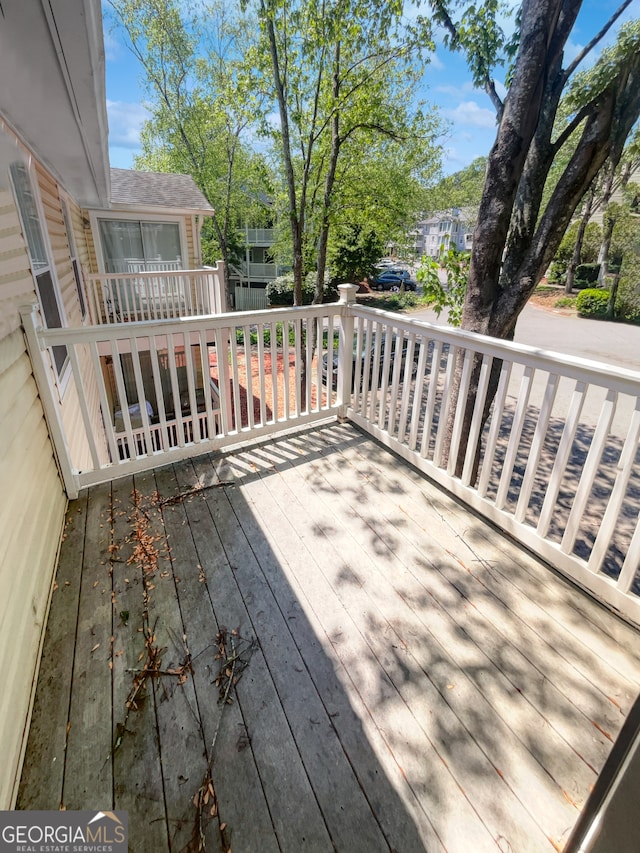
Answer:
[{"left": 0, "top": 183, "right": 66, "bottom": 809}]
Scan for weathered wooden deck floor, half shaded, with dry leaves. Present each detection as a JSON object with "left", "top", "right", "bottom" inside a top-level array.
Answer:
[{"left": 18, "top": 424, "right": 640, "bottom": 853}]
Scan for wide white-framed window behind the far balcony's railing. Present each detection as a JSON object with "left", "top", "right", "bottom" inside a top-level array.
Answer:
[{"left": 98, "top": 219, "right": 182, "bottom": 273}]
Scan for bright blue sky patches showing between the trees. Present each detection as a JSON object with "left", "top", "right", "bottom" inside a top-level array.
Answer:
[{"left": 105, "top": 0, "right": 640, "bottom": 173}]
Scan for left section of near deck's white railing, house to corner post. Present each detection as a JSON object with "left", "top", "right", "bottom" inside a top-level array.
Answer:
[{"left": 23, "top": 304, "right": 340, "bottom": 495}]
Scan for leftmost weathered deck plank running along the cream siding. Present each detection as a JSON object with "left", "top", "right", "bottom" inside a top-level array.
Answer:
[{"left": 17, "top": 490, "right": 88, "bottom": 809}]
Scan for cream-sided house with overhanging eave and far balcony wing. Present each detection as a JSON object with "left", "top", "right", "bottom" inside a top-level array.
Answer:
[{"left": 0, "top": 0, "right": 219, "bottom": 809}]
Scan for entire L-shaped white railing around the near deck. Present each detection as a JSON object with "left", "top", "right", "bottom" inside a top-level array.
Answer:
[{"left": 23, "top": 286, "right": 640, "bottom": 625}]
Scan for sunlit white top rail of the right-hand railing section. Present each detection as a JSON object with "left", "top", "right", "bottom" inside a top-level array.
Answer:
[{"left": 352, "top": 306, "right": 640, "bottom": 396}]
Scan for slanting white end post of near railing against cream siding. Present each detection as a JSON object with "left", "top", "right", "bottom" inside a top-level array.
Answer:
[{"left": 20, "top": 305, "right": 78, "bottom": 500}]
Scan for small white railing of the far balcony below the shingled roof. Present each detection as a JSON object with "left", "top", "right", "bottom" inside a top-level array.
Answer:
[{"left": 85, "top": 264, "right": 226, "bottom": 325}]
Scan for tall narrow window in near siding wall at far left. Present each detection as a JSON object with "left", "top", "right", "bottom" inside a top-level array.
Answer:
[{"left": 9, "top": 163, "right": 67, "bottom": 377}]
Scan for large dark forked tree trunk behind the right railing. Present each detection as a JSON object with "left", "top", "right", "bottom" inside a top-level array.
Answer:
[{"left": 447, "top": 15, "right": 640, "bottom": 476}]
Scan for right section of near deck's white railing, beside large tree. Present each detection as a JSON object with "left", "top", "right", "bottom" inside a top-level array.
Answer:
[{"left": 348, "top": 308, "right": 640, "bottom": 624}]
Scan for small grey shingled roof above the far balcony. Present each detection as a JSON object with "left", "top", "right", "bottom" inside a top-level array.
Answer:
[{"left": 111, "top": 169, "right": 213, "bottom": 212}]
